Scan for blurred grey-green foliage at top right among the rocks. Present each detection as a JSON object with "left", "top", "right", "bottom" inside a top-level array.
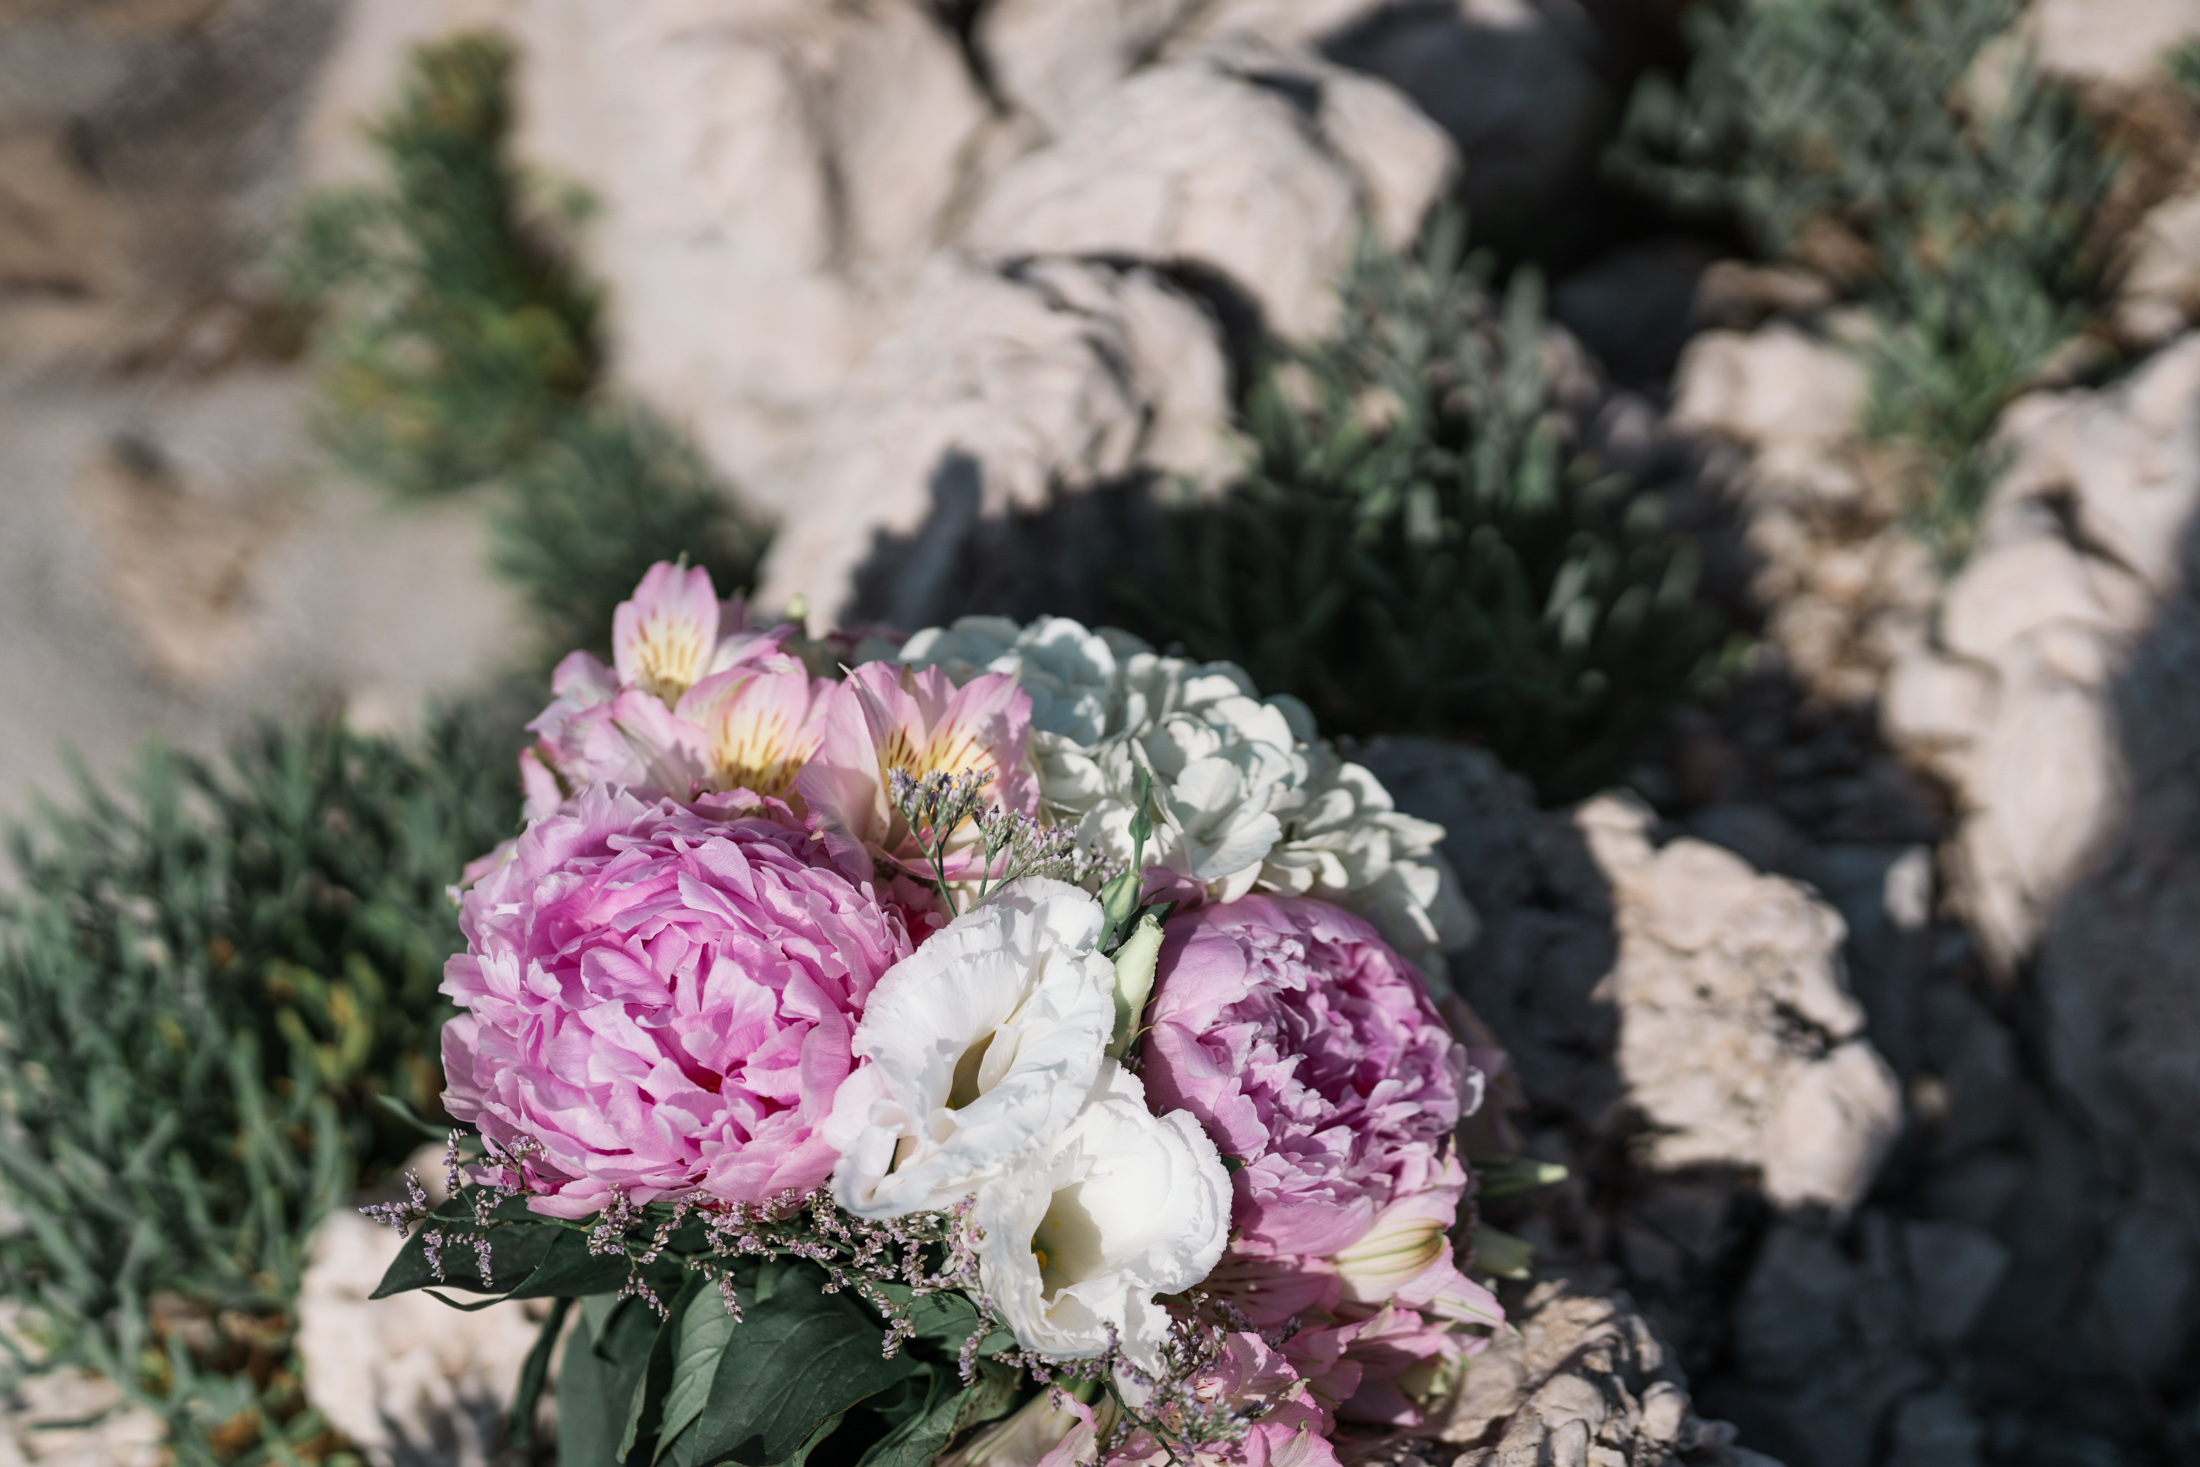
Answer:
[{"left": 1617, "top": 0, "right": 2110, "bottom": 559}]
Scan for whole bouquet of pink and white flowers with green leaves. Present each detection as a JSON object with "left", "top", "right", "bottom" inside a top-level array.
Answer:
[{"left": 378, "top": 565, "right": 1503, "bottom": 1467}]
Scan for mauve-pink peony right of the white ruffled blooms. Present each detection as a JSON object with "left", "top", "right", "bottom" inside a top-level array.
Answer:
[{"left": 1144, "top": 895, "right": 1481, "bottom": 1256}]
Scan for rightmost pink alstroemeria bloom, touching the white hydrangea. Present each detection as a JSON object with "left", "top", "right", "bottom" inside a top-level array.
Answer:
[{"left": 794, "top": 662, "right": 1038, "bottom": 880}]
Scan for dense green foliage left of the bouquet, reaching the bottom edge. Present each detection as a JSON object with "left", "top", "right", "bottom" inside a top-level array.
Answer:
[{"left": 0, "top": 715, "right": 517, "bottom": 1463}]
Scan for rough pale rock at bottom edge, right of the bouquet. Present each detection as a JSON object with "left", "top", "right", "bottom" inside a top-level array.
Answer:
[{"left": 1430, "top": 1278, "right": 1773, "bottom": 1467}]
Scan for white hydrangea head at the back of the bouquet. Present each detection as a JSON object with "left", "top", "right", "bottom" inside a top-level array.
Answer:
[{"left": 900, "top": 616, "right": 1474, "bottom": 988}]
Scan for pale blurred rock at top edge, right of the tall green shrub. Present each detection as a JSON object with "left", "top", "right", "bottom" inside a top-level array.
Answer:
[{"left": 517, "top": 0, "right": 1014, "bottom": 512}]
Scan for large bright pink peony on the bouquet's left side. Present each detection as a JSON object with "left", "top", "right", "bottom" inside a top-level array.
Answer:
[{"left": 442, "top": 787, "right": 909, "bottom": 1218}]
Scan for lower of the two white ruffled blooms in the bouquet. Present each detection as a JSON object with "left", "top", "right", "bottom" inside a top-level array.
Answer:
[{"left": 975, "top": 1060, "right": 1230, "bottom": 1372}]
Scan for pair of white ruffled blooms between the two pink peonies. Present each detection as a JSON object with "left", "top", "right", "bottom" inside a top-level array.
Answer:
[{"left": 825, "top": 878, "right": 1230, "bottom": 1372}]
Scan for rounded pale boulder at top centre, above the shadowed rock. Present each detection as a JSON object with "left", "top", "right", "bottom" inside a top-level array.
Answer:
[{"left": 964, "top": 40, "right": 1454, "bottom": 337}]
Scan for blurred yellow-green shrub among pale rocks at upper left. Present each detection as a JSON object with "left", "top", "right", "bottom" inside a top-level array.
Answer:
[{"left": 284, "top": 35, "right": 763, "bottom": 647}]
